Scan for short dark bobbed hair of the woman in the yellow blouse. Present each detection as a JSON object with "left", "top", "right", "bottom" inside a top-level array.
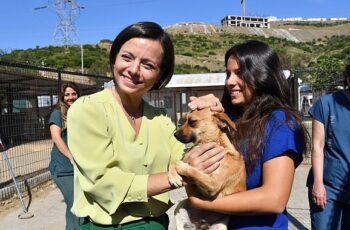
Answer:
[{"left": 109, "top": 22, "right": 175, "bottom": 90}]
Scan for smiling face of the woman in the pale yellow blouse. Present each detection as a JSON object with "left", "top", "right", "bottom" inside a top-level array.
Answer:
[{"left": 114, "top": 38, "right": 163, "bottom": 96}]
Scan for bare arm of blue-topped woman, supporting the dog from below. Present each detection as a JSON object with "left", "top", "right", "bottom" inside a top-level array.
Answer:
[{"left": 188, "top": 152, "right": 295, "bottom": 214}]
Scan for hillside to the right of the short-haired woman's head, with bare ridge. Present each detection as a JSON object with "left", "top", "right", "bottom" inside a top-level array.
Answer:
[{"left": 166, "top": 22, "right": 350, "bottom": 73}]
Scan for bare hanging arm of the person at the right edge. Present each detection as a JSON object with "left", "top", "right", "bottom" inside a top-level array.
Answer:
[{"left": 311, "top": 119, "right": 327, "bottom": 208}]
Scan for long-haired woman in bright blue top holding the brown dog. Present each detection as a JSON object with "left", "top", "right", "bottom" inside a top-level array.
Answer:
[{"left": 188, "top": 40, "right": 307, "bottom": 229}]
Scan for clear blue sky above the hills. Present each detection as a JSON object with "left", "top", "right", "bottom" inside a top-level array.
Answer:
[{"left": 0, "top": 0, "right": 350, "bottom": 53}]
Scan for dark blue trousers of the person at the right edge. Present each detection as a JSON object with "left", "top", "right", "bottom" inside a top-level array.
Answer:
[{"left": 308, "top": 186, "right": 350, "bottom": 230}]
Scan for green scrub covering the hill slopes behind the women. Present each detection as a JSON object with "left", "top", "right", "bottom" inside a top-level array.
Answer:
[{"left": 0, "top": 32, "right": 350, "bottom": 75}]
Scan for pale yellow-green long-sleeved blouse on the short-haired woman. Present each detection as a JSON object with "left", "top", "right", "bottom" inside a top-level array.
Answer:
[{"left": 67, "top": 89, "right": 185, "bottom": 225}]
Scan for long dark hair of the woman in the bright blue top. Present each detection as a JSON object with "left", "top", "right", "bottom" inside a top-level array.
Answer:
[{"left": 221, "top": 40, "right": 306, "bottom": 172}]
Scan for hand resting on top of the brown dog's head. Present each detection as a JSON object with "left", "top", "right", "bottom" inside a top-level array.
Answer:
[{"left": 188, "top": 94, "right": 224, "bottom": 112}]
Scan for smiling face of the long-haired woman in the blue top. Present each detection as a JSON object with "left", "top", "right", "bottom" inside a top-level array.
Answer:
[{"left": 225, "top": 56, "right": 253, "bottom": 106}]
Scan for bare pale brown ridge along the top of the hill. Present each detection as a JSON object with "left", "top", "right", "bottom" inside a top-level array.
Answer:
[{"left": 165, "top": 23, "right": 350, "bottom": 42}]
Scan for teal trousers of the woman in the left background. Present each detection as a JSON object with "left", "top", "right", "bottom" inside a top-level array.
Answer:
[{"left": 52, "top": 174, "right": 79, "bottom": 230}]
